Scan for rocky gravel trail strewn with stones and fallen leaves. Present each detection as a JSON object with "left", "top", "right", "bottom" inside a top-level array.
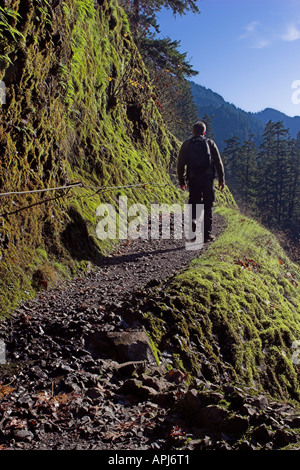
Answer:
[{"left": 0, "top": 217, "right": 300, "bottom": 451}]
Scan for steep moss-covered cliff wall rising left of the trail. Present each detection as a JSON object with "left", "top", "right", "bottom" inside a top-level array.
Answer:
[{"left": 0, "top": 0, "right": 177, "bottom": 314}]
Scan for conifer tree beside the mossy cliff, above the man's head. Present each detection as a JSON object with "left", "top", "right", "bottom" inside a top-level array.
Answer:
[{"left": 119, "top": 0, "right": 199, "bottom": 139}]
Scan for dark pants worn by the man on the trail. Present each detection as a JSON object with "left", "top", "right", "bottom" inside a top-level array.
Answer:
[{"left": 188, "top": 175, "right": 215, "bottom": 238}]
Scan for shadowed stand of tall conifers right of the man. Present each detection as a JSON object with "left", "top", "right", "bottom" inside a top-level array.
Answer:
[{"left": 223, "top": 121, "right": 300, "bottom": 240}]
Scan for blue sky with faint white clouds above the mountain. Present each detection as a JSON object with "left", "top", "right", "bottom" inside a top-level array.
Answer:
[{"left": 158, "top": 0, "right": 300, "bottom": 116}]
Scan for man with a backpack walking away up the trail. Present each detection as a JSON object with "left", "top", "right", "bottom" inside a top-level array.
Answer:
[{"left": 177, "top": 121, "right": 225, "bottom": 243}]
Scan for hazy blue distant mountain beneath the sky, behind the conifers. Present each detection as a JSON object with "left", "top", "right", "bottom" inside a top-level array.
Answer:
[{"left": 190, "top": 82, "right": 300, "bottom": 150}]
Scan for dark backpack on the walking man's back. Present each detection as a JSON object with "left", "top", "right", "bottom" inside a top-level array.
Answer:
[{"left": 187, "top": 136, "right": 212, "bottom": 177}]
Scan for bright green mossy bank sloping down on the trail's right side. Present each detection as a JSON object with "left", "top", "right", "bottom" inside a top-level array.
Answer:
[{"left": 139, "top": 204, "right": 300, "bottom": 399}]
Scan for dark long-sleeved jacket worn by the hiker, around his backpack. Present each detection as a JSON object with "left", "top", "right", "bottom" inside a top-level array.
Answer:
[{"left": 177, "top": 135, "right": 225, "bottom": 186}]
